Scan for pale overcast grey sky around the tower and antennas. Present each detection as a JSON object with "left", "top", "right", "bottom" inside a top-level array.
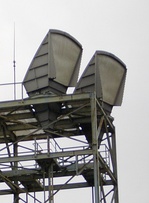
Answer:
[{"left": 0, "top": 0, "right": 149, "bottom": 203}]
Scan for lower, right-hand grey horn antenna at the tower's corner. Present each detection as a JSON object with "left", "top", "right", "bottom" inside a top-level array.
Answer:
[{"left": 74, "top": 51, "right": 126, "bottom": 106}]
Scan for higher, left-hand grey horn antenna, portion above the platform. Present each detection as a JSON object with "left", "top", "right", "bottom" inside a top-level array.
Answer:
[{"left": 23, "top": 30, "right": 82, "bottom": 96}]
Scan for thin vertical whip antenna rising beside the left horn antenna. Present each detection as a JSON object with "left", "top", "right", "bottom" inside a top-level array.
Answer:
[{"left": 13, "top": 23, "right": 16, "bottom": 99}]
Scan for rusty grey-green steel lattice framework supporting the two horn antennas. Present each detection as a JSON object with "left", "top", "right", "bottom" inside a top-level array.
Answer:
[{"left": 0, "top": 93, "right": 118, "bottom": 203}]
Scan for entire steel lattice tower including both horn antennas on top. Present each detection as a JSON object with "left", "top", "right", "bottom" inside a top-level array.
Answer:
[{"left": 0, "top": 30, "right": 126, "bottom": 203}]
